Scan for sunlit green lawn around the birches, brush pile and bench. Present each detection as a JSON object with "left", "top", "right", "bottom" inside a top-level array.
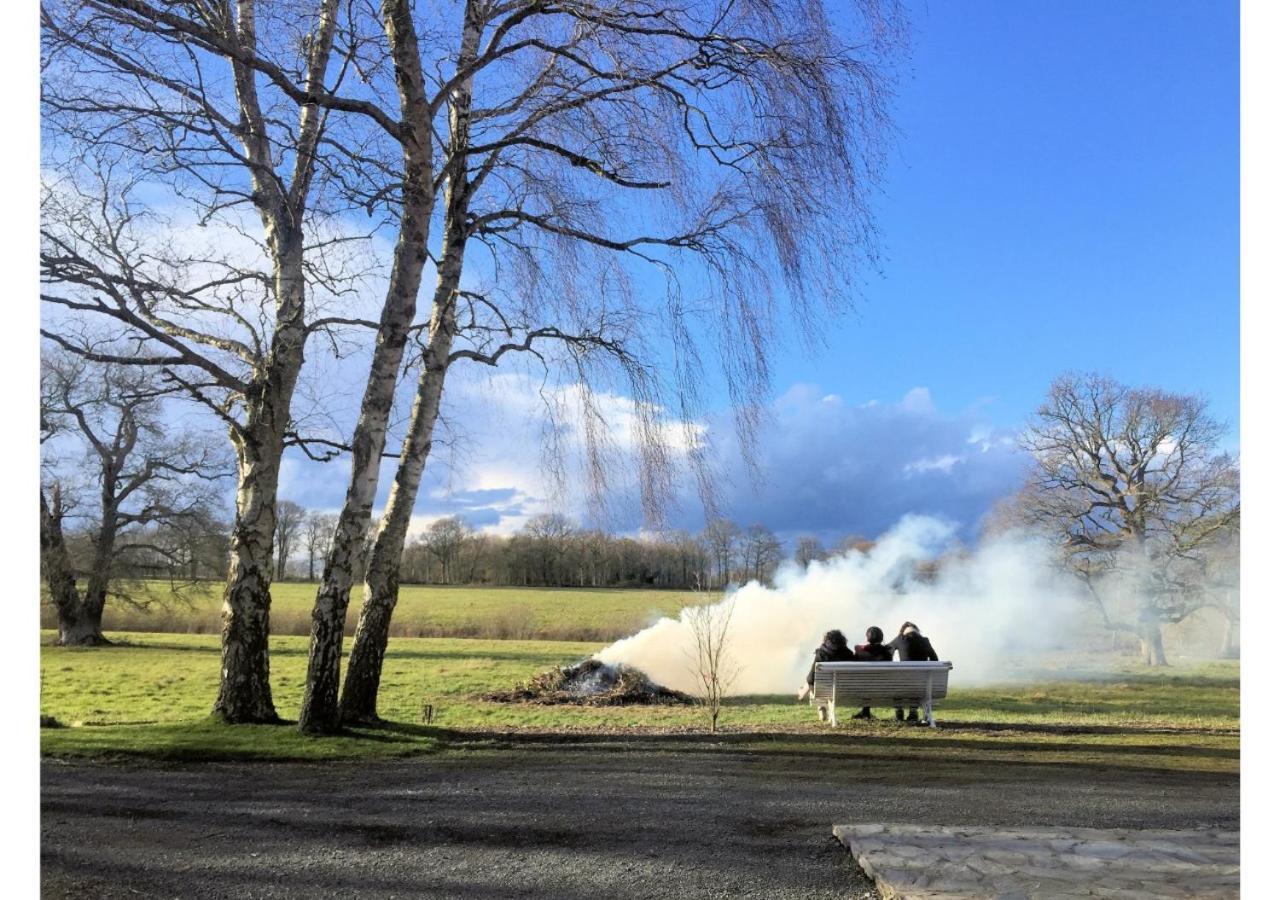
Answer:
[{"left": 41, "top": 634, "right": 1239, "bottom": 772}]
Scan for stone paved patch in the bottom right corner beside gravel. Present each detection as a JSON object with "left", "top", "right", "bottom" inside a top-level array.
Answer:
[{"left": 833, "top": 824, "right": 1240, "bottom": 900}]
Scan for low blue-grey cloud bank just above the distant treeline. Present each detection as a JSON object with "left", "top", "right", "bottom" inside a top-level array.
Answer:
[{"left": 277, "top": 384, "right": 1024, "bottom": 542}]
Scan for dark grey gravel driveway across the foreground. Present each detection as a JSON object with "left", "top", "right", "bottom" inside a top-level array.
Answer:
[{"left": 41, "top": 739, "right": 1239, "bottom": 900}]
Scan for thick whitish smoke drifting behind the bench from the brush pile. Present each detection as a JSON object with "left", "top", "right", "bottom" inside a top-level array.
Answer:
[{"left": 596, "top": 516, "right": 1080, "bottom": 694}]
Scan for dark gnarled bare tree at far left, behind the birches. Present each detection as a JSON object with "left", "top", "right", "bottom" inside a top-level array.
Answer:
[{"left": 40, "top": 351, "right": 229, "bottom": 644}]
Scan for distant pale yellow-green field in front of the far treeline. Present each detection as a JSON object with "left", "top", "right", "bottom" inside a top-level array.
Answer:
[{"left": 41, "top": 581, "right": 696, "bottom": 641}]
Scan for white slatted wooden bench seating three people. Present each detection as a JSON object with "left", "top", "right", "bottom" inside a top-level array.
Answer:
[{"left": 810, "top": 662, "right": 951, "bottom": 728}]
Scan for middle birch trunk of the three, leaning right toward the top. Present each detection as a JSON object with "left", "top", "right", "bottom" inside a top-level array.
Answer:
[{"left": 298, "top": 0, "right": 435, "bottom": 734}]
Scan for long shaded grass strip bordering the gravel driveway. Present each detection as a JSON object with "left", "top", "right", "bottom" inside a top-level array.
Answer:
[{"left": 42, "top": 719, "right": 1239, "bottom": 781}]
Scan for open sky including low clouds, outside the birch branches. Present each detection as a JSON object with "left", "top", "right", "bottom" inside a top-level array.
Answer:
[{"left": 282, "top": 1, "right": 1239, "bottom": 540}]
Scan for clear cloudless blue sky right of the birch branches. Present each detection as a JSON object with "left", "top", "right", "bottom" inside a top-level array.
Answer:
[{"left": 777, "top": 1, "right": 1239, "bottom": 442}]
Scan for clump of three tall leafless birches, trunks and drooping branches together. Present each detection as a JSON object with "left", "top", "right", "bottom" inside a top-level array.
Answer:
[{"left": 42, "top": 0, "right": 902, "bottom": 731}]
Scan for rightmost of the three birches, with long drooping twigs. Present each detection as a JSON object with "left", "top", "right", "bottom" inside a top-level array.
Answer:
[{"left": 335, "top": 0, "right": 897, "bottom": 727}]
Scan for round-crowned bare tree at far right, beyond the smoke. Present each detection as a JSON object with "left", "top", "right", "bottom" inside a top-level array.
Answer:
[{"left": 1015, "top": 375, "right": 1240, "bottom": 666}]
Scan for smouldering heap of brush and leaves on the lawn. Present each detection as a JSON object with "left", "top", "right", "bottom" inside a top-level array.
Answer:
[{"left": 483, "top": 659, "right": 694, "bottom": 707}]
